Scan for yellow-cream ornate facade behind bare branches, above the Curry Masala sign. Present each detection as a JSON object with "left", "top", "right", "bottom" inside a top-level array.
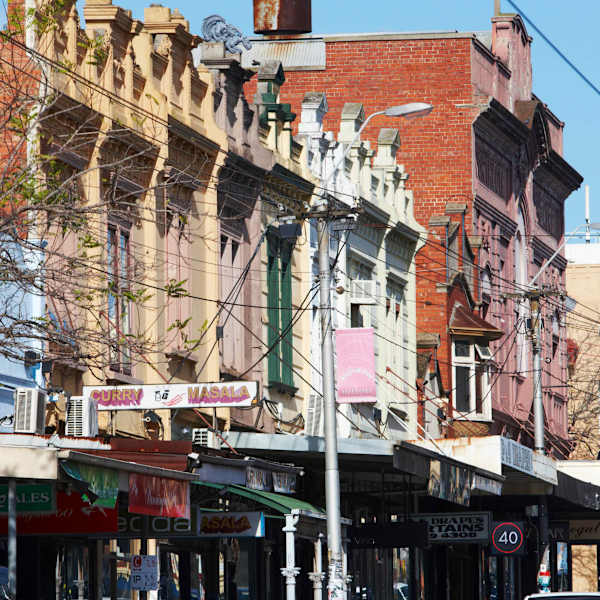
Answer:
[{"left": 38, "top": 0, "right": 227, "bottom": 439}]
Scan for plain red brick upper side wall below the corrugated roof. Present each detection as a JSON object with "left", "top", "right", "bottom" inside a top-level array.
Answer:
[{"left": 246, "top": 38, "right": 474, "bottom": 225}]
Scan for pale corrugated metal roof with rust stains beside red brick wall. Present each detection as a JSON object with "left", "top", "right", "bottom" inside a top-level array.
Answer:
[{"left": 242, "top": 39, "right": 327, "bottom": 71}]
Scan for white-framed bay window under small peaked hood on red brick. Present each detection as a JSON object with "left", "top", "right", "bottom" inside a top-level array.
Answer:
[{"left": 452, "top": 340, "right": 492, "bottom": 420}]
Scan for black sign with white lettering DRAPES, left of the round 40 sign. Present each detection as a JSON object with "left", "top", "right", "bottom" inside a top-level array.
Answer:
[{"left": 418, "top": 512, "right": 490, "bottom": 544}]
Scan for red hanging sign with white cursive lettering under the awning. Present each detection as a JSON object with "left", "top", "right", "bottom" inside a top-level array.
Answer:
[{"left": 129, "top": 473, "right": 190, "bottom": 519}]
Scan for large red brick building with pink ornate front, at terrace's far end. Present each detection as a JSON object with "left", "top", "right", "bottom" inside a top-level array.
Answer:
[{"left": 244, "top": 14, "right": 581, "bottom": 455}]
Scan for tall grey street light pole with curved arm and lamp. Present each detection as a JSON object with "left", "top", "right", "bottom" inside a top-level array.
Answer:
[{"left": 317, "top": 102, "right": 433, "bottom": 600}]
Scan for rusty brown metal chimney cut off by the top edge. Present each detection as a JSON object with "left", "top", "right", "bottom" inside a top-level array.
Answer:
[{"left": 254, "top": 0, "right": 312, "bottom": 35}]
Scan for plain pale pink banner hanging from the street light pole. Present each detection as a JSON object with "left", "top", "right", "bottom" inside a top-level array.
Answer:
[{"left": 335, "top": 327, "right": 377, "bottom": 404}]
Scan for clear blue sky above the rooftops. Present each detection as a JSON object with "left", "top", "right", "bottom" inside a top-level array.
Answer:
[{"left": 85, "top": 0, "right": 600, "bottom": 238}]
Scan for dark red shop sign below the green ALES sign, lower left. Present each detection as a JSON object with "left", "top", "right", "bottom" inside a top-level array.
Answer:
[{"left": 0, "top": 492, "right": 119, "bottom": 536}]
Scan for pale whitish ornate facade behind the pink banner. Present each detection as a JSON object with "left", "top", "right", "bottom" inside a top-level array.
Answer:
[{"left": 298, "top": 92, "right": 424, "bottom": 440}]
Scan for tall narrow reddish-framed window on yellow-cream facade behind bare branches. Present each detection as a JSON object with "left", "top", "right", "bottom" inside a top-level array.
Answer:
[{"left": 106, "top": 223, "right": 131, "bottom": 375}]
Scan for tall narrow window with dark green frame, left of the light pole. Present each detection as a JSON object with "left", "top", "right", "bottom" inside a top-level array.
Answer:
[{"left": 267, "top": 229, "right": 296, "bottom": 393}]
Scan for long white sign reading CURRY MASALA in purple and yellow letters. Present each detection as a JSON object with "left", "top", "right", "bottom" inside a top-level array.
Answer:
[{"left": 83, "top": 381, "right": 258, "bottom": 410}]
